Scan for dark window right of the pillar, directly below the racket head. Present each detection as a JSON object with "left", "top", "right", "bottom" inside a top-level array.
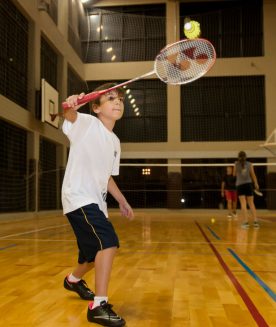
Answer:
[{"left": 181, "top": 76, "right": 266, "bottom": 142}]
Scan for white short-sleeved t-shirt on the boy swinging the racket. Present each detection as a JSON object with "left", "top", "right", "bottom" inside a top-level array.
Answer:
[{"left": 62, "top": 113, "right": 121, "bottom": 217}]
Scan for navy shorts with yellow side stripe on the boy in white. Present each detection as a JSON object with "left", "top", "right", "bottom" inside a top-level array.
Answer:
[{"left": 66, "top": 203, "right": 119, "bottom": 263}]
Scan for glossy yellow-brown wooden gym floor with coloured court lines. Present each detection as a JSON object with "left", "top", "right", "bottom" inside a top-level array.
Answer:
[{"left": 0, "top": 210, "right": 276, "bottom": 327}]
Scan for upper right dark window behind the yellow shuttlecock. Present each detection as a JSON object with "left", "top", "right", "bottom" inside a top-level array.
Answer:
[{"left": 180, "top": 0, "right": 264, "bottom": 58}]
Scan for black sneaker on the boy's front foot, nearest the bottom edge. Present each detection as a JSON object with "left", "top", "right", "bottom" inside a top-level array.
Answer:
[{"left": 87, "top": 301, "right": 126, "bottom": 327}]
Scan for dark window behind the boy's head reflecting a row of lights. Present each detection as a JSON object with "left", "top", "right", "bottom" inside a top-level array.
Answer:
[{"left": 89, "top": 80, "right": 167, "bottom": 142}]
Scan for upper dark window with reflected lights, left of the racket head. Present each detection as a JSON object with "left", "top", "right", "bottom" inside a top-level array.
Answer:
[{"left": 81, "top": 5, "right": 166, "bottom": 62}]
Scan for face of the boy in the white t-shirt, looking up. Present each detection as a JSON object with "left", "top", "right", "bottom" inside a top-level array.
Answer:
[{"left": 94, "top": 90, "right": 124, "bottom": 121}]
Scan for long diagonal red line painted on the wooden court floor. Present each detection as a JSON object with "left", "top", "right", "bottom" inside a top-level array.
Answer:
[{"left": 195, "top": 221, "right": 269, "bottom": 327}]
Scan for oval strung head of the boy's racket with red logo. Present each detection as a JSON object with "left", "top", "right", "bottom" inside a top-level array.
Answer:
[{"left": 155, "top": 39, "right": 216, "bottom": 84}]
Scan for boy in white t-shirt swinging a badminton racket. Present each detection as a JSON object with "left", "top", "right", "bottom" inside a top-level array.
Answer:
[{"left": 62, "top": 83, "right": 134, "bottom": 326}]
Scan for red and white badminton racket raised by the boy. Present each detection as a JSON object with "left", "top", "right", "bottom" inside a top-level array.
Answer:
[{"left": 62, "top": 38, "right": 216, "bottom": 109}]
